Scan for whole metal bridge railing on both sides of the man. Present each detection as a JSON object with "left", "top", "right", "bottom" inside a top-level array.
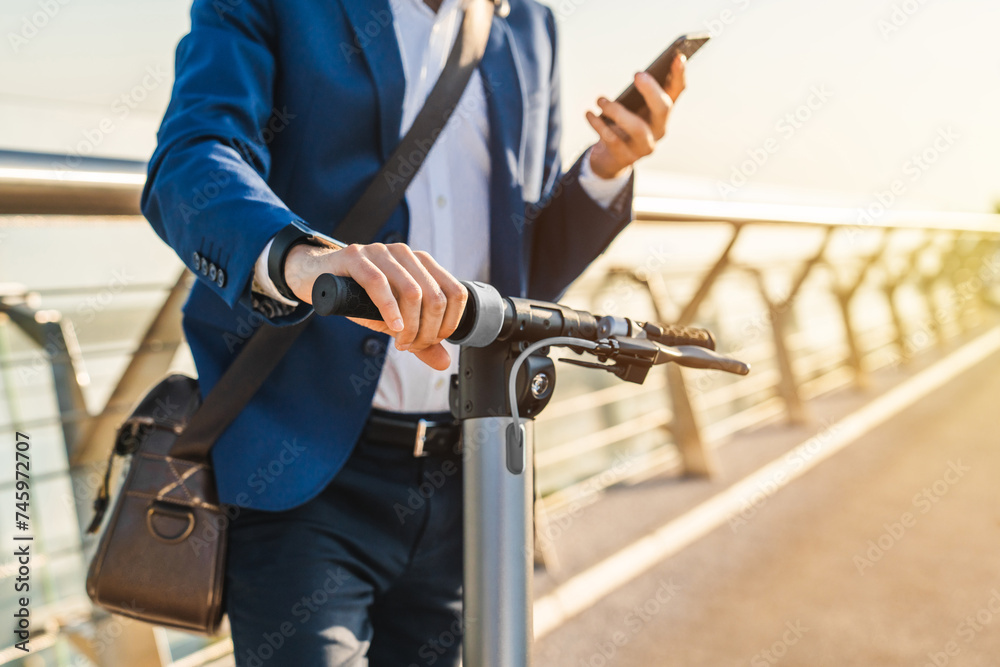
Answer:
[{"left": 0, "top": 154, "right": 1000, "bottom": 667}]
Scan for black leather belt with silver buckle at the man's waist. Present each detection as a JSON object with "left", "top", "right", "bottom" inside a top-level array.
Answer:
[{"left": 361, "top": 409, "right": 462, "bottom": 457}]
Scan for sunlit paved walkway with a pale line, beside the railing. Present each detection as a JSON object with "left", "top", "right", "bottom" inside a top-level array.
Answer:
[{"left": 535, "top": 332, "right": 1000, "bottom": 667}]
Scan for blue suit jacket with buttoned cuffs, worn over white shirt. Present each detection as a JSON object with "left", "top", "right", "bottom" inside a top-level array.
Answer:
[{"left": 142, "top": 0, "right": 631, "bottom": 510}]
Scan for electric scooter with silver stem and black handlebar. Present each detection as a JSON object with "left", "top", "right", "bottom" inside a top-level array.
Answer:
[{"left": 312, "top": 274, "right": 750, "bottom": 667}]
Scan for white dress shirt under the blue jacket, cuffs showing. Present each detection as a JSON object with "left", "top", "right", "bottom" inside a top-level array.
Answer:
[{"left": 254, "top": 0, "right": 631, "bottom": 412}]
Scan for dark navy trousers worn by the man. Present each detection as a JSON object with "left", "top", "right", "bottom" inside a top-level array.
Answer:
[{"left": 226, "top": 428, "right": 462, "bottom": 667}]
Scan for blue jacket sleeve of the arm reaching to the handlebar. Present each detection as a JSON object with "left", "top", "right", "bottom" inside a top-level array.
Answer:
[{"left": 142, "top": 0, "right": 309, "bottom": 323}]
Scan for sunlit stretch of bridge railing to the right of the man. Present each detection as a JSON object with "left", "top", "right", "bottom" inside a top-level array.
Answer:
[{"left": 536, "top": 198, "right": 1000, "bottom": 566}]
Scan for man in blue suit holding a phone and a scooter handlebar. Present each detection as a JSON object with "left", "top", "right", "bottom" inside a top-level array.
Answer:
[{"left": 142, "top": 0, "right": 684, "bottom": 667}]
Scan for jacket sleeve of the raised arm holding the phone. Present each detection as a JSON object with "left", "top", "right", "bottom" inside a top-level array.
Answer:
[{"left": 524, "top": 8, "right": 634, "bottom": 300}]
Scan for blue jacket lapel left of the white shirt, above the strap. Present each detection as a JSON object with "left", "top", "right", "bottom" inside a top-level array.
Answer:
[{"left": 340, "top": 0, "right": 406, "bottom": 160}]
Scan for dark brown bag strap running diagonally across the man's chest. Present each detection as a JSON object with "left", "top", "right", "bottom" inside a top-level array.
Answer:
[{"left": 170, "top": 0, "right": 499, "bottom": 460}]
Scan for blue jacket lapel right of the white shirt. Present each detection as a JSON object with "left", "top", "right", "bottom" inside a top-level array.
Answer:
[{"left": 479, "top": 16, "right": 526, "bottom": 294}]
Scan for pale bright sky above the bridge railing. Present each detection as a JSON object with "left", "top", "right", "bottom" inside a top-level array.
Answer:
[{"left": 0, "top": 0, "right": 1000, "bottom": 212}]
